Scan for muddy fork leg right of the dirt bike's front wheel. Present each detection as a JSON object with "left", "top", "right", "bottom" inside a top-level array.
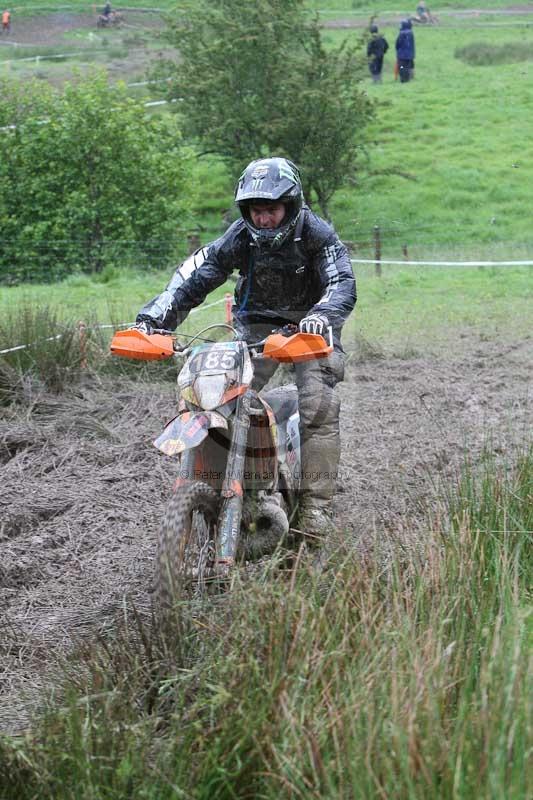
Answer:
[{"left": 217, "top": 391, "right": 251, "bottom": 567}]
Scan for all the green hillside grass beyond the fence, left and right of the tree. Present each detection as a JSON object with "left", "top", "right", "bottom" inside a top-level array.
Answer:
[{"left": 0, "top": 0, "right": 533, "bottom": 260}]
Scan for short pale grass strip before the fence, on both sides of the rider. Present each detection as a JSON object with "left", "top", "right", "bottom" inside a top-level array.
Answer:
[{"left": 0, "top": 265, "right": 533, "bottom": 355}]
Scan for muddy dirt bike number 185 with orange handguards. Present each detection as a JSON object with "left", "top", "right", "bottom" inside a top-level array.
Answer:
[{"left": 111, "top": 325, "right": 333, "bottom": 609}]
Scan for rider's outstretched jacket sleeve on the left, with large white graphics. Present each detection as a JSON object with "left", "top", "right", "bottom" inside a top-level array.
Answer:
[{"left": 136, "top": 237, "right": 233, "bottom": 330}]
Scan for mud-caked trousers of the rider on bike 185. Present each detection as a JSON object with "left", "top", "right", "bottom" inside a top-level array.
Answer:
[{"left": 252, "top": 350, "right": 344, "bottom": 508}]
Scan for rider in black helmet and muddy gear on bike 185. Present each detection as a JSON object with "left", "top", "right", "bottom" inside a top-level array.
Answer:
[{"left": 136, "top": 157, "right": 356, "bottom": 536}]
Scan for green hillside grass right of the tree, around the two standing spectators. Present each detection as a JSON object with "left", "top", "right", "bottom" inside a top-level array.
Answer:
[{"left": 324, "top": 18, "right": 533, "bottom": 260}]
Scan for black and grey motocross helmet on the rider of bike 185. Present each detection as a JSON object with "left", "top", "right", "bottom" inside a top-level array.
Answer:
[{"left": 235, "top": 158, "right": 303, "bottom": 249}]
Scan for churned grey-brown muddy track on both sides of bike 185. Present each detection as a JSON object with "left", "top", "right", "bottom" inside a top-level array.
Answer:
[{"left": 0, "top": 337, "right": 533, "bottom": 731}]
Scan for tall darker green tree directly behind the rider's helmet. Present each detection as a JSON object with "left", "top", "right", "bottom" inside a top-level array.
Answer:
[{"left": 159, "top": 0, "right": 373, "bottom": 216}]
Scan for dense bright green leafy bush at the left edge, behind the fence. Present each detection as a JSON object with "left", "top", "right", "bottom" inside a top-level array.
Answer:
[{"left": 0, "top": 73, "right": 195, "bottom": 283}]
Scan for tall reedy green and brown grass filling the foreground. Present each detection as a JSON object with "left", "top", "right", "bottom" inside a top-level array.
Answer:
[{"left": 0, "top": 450, "right": 533, "bottom": 800}]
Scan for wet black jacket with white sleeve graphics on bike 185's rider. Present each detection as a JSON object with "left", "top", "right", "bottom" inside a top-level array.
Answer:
[{"left": 137, "top": 207, "right": 356, "bottom": 344}]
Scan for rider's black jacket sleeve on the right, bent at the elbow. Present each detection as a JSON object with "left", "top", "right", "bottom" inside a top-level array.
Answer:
[{"left": 309, "top": 231, "right": 357, "bottom": 329}]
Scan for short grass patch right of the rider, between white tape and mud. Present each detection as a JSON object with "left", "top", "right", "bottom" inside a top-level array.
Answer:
[{"left": 344, "top": 265, "right": 533, "bottom": 355}]
